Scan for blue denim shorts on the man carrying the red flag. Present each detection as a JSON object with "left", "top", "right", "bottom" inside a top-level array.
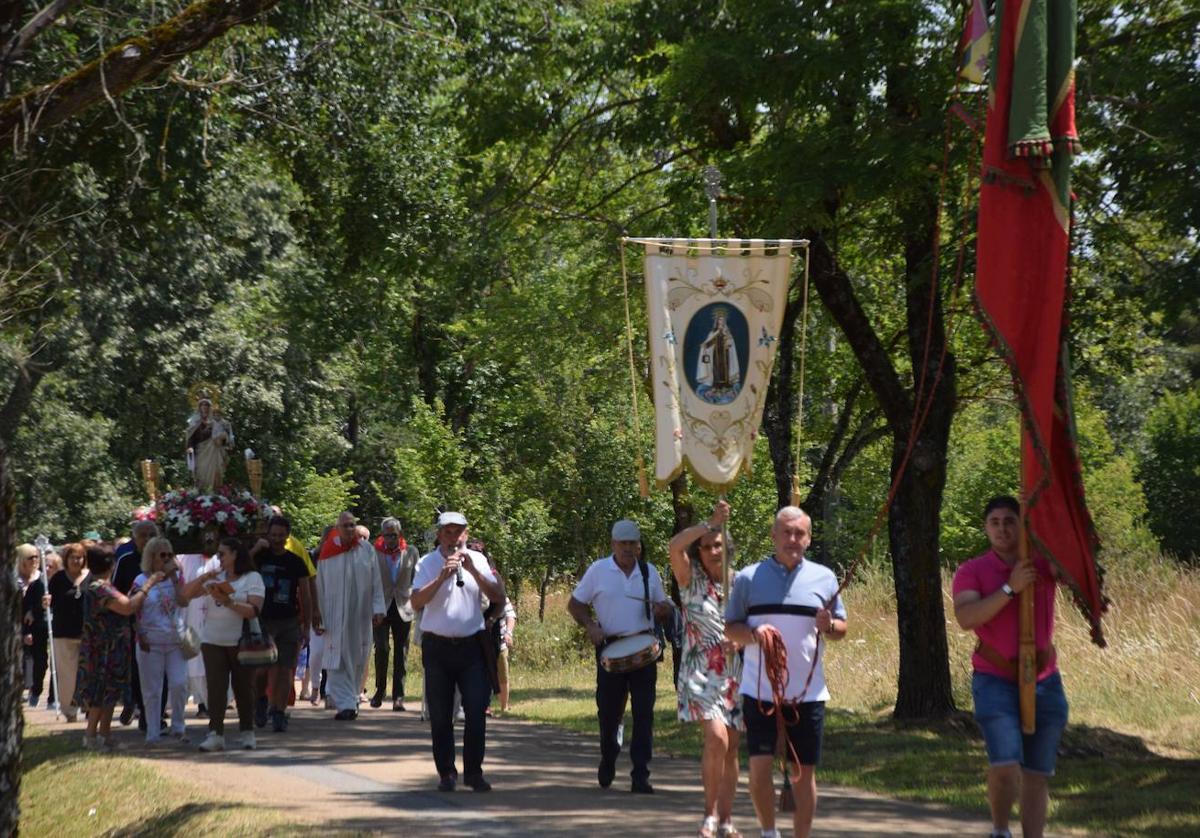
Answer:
[{"left": 971, "top": 672, "right": 1067, "bottom": 776}]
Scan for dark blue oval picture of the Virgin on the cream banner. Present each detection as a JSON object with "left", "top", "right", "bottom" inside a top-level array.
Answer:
[{"left": 683, "top": 303, "right": 750, "bottom": 405}]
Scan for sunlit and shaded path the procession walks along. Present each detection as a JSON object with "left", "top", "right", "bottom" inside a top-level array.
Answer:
[{"left": 28, "top": 706, "right": 1003, "bottom": 838}]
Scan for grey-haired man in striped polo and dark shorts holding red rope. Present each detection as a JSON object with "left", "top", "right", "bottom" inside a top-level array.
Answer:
[{"left": 725, "top": 507, "right": 846, "bottom": 838}]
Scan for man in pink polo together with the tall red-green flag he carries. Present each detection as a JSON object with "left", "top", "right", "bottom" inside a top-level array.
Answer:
[{"left": 954, "top": 0, "right": 1105, "bottom": 838}]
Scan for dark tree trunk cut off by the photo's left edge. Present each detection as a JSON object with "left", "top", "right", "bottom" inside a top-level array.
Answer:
[{"left": 0, "top": 439, "right": 25, "bottom": 836}]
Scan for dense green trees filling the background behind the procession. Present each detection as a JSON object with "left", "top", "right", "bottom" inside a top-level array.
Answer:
[{"left": 0, "top": 0, "right": 1200, "bottom": 749}]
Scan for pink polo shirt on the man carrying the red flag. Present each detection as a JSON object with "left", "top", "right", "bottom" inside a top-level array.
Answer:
[{"left": 953, "top": 550, "right": 1058, "bottom": 681}]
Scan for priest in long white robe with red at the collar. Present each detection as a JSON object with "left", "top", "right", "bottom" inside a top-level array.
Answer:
[{"left": 314, "top": 511, "right": 386, "bottom": 722}]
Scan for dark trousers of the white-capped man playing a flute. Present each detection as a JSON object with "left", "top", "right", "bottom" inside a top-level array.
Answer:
[{"left": 421, "top": 633, "right": 492, "bottom": 779}]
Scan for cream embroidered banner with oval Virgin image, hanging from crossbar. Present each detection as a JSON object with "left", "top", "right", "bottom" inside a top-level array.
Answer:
[{"left": 636, "top": 239, "right": 797, "bottom": 492}]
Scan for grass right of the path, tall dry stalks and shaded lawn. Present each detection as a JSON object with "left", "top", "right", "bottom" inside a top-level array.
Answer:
[{"left": 501, "top": 568, "right": 1200, "bottom": 838}]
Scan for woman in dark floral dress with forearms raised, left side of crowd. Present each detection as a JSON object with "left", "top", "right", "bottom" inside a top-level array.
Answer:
[{"left": 74, "top": 547, "right": 163, "bottom": 749}]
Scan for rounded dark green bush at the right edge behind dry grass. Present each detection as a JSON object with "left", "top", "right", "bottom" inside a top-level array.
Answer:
[{"left": 1140, "top": 385, "right": 1200, "bottom": 559}]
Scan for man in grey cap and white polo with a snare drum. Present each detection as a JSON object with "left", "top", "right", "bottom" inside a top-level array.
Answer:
[{"left": 566, "top": 520, "right": 671, "bottom": 795}]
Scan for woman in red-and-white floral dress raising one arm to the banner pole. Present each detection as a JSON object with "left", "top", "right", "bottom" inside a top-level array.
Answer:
[{"left": 671, "top": 501, "right": 744, "bottom": 838}]
